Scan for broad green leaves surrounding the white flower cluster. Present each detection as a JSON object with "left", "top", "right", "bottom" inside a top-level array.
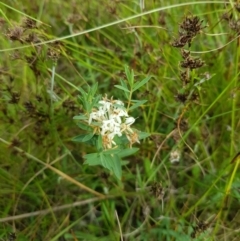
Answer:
[{"left": 72, "top": 66, "right": 150, "bottom": 179}]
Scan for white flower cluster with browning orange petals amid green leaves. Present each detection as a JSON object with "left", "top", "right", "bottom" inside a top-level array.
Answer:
[{"left": 88, "top": 97, "right": 139, "bottom": 149}]
